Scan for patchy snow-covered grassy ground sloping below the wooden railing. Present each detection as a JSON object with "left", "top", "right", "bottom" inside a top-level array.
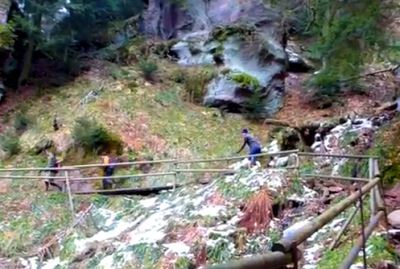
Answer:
[{"left": 19, "top": 115, "right": 388, "bottom": 269}]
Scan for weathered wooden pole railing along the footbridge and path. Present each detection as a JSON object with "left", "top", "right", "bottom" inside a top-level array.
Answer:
[{"left": 0, "top": 150, "right": 387, "bottom": 269}]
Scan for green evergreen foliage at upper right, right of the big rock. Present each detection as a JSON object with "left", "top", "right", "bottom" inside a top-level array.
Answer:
[{"left": 310, "top": 0, "right": 385, "bottom": 88}]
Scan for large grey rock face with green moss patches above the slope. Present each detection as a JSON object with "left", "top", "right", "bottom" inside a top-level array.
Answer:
[{"left": 144, "top": 0, "right": 287, "bottom": 116}]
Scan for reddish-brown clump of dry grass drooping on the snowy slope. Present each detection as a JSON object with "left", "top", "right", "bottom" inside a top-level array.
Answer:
[{"left": 239, "top": 188, "right": 272, "bottom": 233}]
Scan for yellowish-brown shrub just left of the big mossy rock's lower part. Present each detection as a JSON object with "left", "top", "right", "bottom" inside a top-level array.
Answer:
[{"left": 183, "top": 67, "right": 216, "bottom": 103}]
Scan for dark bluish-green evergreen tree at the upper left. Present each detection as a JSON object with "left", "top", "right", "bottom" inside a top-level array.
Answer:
[{"left": 12, "top": 0, "right": 144, "bottom": 86}]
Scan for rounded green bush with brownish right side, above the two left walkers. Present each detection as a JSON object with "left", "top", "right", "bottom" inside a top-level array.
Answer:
[{"left": 72, "top": 117, "right": 122, "bottom": 154}]
